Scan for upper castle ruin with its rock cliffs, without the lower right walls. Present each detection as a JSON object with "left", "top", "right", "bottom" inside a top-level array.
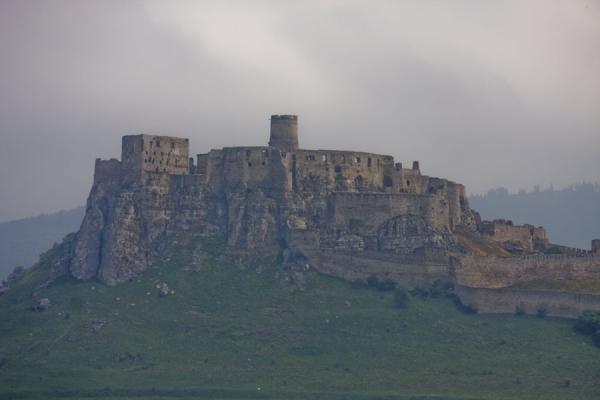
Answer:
[{"left": 68, "top": 115, "right": 477, "bottom": 283}]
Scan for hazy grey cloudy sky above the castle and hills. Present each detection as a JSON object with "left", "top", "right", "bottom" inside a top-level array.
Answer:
[{"left": 0, "top": 0, "right": 600, "bottom": 220}]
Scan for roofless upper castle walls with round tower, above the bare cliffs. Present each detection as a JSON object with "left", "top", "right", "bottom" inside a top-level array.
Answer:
[{"left": 115, "top": 115, "right": 465, "bottom": 219}]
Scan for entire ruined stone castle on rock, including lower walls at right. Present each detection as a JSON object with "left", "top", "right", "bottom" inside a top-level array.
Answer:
[{"left": 52, "top": 115, "right": 600, "bottom": 315}]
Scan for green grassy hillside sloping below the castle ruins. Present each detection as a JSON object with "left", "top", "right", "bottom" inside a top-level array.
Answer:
[{"left": 0, "top": 236, "right": 600, "bottom": 400}]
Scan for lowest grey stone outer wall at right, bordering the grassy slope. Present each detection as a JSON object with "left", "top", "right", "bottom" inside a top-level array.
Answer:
[{"left": 455, "top": 285, "right": 600, "bottom": 318}]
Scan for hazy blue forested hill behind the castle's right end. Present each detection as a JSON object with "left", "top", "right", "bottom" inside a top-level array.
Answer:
[{"left": 469, "top": 183, "right": 600, "bottom": 249}]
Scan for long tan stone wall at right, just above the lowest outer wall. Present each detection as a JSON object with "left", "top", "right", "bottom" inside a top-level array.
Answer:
[{"left": 454, "top": 255, "right": 600, "bottom": 288}]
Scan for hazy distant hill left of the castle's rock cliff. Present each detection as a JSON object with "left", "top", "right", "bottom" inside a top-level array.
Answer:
[{"left": 0, "top": 207, "right": 85, "bottom": 280}]
